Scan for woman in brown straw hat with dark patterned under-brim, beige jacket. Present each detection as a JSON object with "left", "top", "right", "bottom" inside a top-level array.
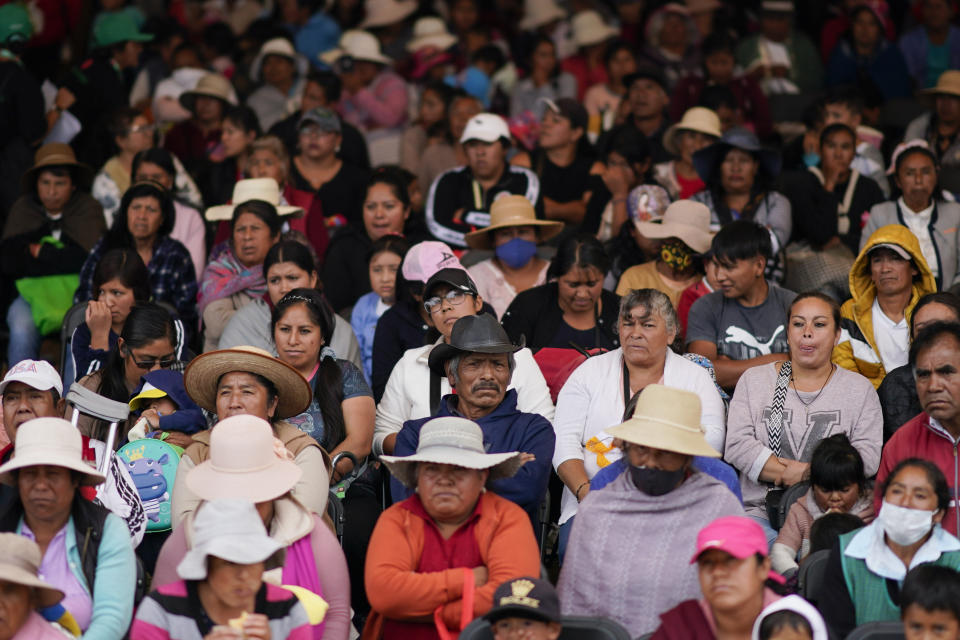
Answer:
[{"left": 171, "top": 347, "right": 330, "bottom": 526}]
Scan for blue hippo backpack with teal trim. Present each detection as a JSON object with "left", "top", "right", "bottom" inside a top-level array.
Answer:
[{"left": 117, "top": 438, "right": 183, "bottom": 531}]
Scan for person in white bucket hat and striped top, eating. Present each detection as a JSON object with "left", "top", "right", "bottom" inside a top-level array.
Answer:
[{"left": 130, "top": 499, "right": 314, "bottom": 640}]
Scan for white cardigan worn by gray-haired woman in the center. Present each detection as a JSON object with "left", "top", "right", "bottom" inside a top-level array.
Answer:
[{"left": 553, "top": 349, "right": 726, "bottom": 524}]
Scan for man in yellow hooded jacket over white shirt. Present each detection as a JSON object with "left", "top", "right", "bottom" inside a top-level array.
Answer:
[{"left": 833, "top": 224, "right": 937, "bottom": 388}]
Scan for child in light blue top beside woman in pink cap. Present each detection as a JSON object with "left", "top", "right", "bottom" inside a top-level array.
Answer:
[{"left": 350, "top": 234, "right": 409, "bottom": 382}]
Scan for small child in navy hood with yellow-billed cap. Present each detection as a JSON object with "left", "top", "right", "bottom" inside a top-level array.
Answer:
[{"left": 127, "top": 369, "right": 207, "bottom": 448}]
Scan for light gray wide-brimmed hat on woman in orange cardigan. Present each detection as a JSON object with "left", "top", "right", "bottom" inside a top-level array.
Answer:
[{"left": 380, "top": 416, "right": 522, "bottom": 488}]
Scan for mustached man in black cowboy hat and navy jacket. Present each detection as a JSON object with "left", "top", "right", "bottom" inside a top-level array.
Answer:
[{"left": 391, "top": 313, "right": 556, "bottom": 531}]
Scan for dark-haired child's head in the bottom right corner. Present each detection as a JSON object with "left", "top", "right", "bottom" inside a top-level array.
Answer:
[{"left": 900, "top": 564, "right": 960, "bottom": 640}]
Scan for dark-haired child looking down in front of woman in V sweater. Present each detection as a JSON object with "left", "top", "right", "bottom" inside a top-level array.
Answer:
[{"left": 770, "top": 433, "right": 874, "bottom": 573}]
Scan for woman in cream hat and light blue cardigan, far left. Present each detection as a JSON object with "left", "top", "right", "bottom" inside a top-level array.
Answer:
[{"left": 0, "top": 418, "right": 137, "bottom": 638}]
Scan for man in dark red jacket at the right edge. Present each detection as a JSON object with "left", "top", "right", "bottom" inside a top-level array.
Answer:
[{"left": 873, "top": 322, "right": 960, "bottom": 535}]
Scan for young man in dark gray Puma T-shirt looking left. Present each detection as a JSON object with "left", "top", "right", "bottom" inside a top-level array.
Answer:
[{"left": 687, "top": 220, "right": 796, "bottom": 391}]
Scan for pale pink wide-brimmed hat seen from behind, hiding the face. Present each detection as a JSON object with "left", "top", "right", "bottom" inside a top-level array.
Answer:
[{"left": 186, "top": 415, "right": 303, "bottom": 502}]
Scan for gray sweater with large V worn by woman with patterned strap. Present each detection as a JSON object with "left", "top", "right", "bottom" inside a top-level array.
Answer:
[{"left": 724, "top": 363, "right": 883, "bottom": 518}]
